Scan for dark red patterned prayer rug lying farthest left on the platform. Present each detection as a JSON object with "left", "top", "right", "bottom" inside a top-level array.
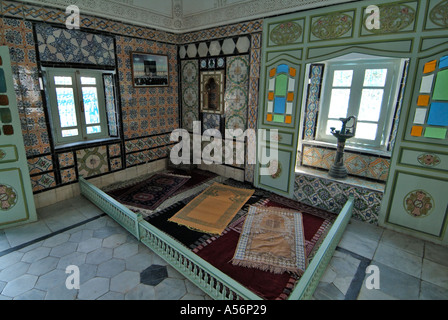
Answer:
[{"left": 115, "top": 173, "right": 190, "bottom": 210}]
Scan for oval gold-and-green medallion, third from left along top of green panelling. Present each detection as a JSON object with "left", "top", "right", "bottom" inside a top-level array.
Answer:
[{"left": 364, "top": 4, "right": 415, "bottom": 34}]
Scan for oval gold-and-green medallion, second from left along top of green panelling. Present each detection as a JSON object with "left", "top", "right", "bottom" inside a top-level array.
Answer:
[{"left": 311, "top": 13, "right": 353, "bottom": 40}]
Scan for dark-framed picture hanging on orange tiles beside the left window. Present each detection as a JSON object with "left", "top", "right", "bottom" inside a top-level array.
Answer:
[{"left": 131, "top": 52, "right": 169, "bottom": 88}]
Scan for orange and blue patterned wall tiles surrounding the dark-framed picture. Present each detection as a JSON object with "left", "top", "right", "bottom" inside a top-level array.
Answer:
[{"left": 116, "top": 36, "right": 179, "bottom": 140}]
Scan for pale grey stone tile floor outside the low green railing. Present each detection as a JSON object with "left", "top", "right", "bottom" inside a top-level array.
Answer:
[{"left": 0, "top": 196, "right": 448, "bottom": 300}]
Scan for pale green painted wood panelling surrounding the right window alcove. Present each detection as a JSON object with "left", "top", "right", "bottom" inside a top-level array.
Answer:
[{"left": 255, "top": 0, "right": 448, "bottom": 243}]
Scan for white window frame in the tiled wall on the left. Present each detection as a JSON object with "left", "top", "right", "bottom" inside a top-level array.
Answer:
[{"left": 42, "top": 67, "right": 111, "bottom": 146}]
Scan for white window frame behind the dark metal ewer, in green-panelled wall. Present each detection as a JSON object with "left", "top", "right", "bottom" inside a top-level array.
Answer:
[{"left": 316, "top": 56, "right": 406, "bottom": 151}]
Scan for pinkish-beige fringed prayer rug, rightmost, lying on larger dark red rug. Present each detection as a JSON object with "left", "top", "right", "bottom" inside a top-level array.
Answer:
[{"left": 232, "top": 206, "right": 306, "bottom": 275}]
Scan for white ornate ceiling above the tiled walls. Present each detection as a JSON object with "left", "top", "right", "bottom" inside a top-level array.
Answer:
[{"left": 22, "top": 0, "right": 353, "bottom": 33}]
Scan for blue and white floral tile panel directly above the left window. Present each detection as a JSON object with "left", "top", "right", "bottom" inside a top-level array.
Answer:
[{"left": 36, "top": 24, "right": 115, "bottom": 66}]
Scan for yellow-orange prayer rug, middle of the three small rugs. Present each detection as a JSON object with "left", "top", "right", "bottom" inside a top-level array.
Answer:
[{"left": 169, "top": 182, "right": 255, "bottom": 235}]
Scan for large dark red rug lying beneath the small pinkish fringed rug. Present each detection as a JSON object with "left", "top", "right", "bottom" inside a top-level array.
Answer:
[{"left": 193, "top": 195, "right": 336, "bottom": 300}]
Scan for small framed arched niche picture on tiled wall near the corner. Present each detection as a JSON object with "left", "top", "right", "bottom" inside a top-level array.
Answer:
[{"left": 201, "top": 70, "right": 224, "bottom": 114}]
